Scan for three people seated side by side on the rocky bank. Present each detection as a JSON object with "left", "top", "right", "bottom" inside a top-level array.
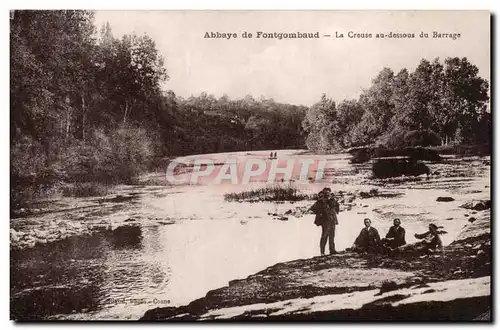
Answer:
[{"left": 347, "top": 218, "right": 443, "bottom": 254}]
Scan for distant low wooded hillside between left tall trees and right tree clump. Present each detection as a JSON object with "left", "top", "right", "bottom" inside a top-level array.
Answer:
[{"left": 170, "top": 93, "right": 307, "bottom": 155}]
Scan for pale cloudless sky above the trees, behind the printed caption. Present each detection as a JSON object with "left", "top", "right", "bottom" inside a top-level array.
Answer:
[{"left": 96, "top": 11, "right": 490, "bottom": 106}]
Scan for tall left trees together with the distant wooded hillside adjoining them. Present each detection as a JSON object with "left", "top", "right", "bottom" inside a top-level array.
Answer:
[{"left": 10, "top": 10, "right": 306, "bottom": 201}]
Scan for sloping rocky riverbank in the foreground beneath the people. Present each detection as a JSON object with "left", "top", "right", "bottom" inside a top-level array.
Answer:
[{"left": 141, "top": 210, "right": 491, "bottom": 321}]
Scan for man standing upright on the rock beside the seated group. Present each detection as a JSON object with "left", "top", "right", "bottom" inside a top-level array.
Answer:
[{"left": 310, "top": 188, "right": 338, "bottom": 256}]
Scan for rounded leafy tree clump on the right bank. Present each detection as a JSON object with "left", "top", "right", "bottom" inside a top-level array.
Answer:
[{"left": 303, "top": 58, "right": 491, "bottom": 152}]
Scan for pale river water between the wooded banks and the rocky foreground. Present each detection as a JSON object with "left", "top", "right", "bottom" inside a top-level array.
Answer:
[{"left": 11, "top": 151, "right": 490, "bottom": 320}]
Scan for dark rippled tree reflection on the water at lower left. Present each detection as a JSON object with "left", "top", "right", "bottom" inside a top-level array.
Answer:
[{"left": 10, "top": 226, "right": 168, "bottom": 320}]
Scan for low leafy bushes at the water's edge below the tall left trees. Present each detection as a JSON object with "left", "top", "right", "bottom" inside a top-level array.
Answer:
[{"left": 11, "top": 128, "right": 154, "bottom": 207}]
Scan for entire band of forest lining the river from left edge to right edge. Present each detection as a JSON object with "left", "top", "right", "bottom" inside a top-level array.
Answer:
[{"left": 10, "top": 10, "right": 491, "bottom": 205}]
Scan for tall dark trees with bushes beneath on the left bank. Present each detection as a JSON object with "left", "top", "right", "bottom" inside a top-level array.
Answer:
[{"left": 10, "top": 11, "right": 167, "bottom": 187}]
